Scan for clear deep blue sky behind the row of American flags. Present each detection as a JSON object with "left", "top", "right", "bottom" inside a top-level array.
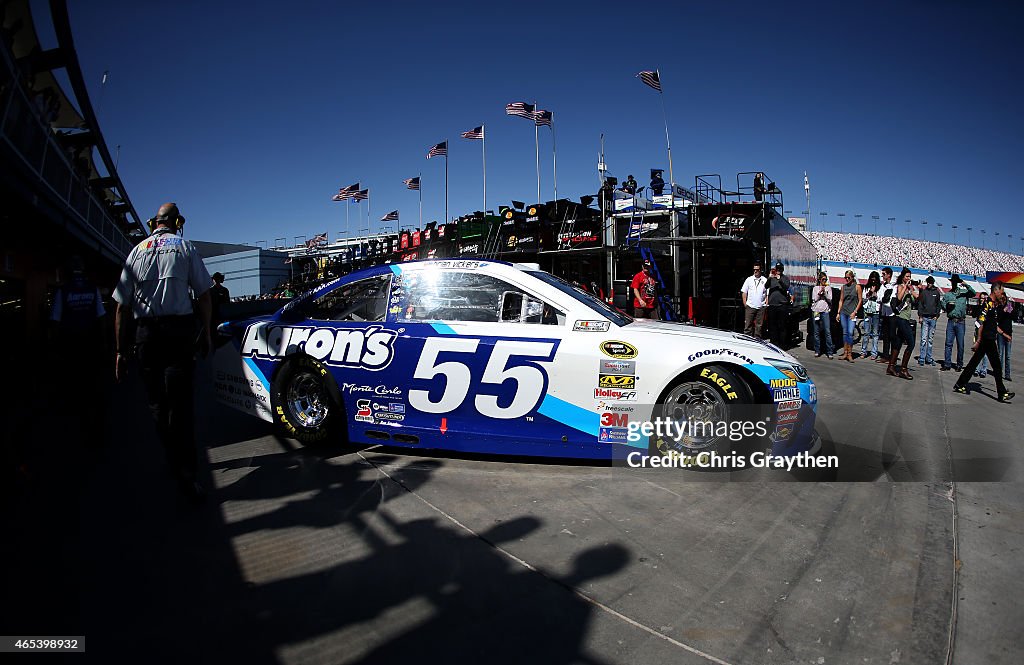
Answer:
[{"left": 46, "top": 0, "right": 1024, "bottom": 252}]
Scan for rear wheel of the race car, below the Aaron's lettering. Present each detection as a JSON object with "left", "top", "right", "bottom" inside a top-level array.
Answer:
[{"left": 270, "top": 356, "right": 345, "bottom": 446}]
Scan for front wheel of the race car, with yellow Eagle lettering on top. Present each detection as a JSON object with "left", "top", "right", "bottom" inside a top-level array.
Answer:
[{"left": 650, "top": 365, "right": 755, "bottom": 461}]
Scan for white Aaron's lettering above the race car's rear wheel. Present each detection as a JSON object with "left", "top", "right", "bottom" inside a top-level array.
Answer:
[{"left": 242, "top": 323, "right": 398, "bottom": 371}]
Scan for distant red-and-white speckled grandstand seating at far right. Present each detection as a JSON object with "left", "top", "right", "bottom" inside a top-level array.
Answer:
[{"left": 803, "top": 231, "right": 1024, "bottom": 280}]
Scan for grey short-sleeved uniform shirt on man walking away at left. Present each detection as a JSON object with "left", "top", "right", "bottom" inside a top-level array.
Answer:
[{"left": 114, "top": 230, "right": 213, "bottom": 319}]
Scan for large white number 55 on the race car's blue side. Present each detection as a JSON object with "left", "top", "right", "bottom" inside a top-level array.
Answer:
[{"left": 409, "top": 337, "right": 555, "bottom": 419}]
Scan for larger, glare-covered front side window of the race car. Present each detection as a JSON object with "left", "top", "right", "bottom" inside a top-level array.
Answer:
[{"left": 397, "top": 271, "right": 565, "bottom": 325}]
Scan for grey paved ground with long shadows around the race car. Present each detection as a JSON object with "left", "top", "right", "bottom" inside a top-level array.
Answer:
[{"left": 0, "top": 315, "right": 1024, "bottom": 665}]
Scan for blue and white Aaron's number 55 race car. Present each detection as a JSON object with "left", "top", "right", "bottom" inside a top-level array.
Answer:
[{"left": 215, "top": 259, "right": 817, "bottom": 458}]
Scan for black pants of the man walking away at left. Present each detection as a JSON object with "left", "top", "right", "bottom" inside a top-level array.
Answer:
[{"left": 135, "top": 317, "right": 198, "bottom": 482}]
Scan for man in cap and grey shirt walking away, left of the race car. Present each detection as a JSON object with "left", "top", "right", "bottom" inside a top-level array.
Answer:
[{"left": 114, "top": 203, "right": 212, "bottom": 499}]
